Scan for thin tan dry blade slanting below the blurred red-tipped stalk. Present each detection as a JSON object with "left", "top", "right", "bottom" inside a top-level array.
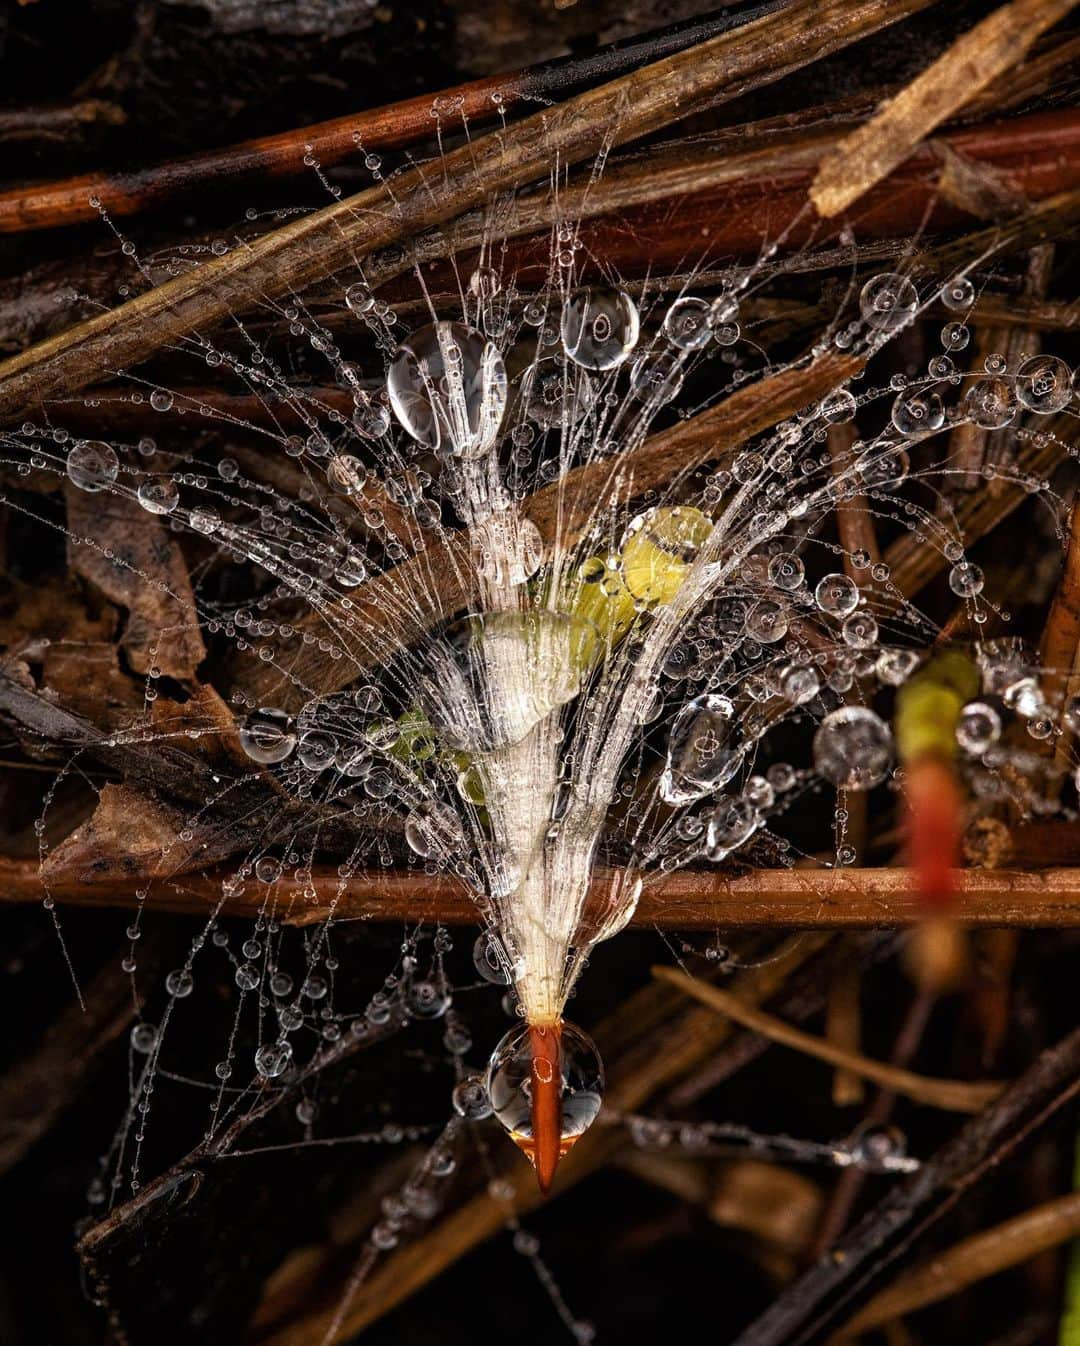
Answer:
[{"left": 653, "top": 968, "right": 1005, "bottom": 1112}]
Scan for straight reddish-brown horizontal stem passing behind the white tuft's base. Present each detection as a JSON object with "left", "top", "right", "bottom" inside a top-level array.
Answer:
[{"left": 0, "top": 860, "right": 1080, "bottom": 930}]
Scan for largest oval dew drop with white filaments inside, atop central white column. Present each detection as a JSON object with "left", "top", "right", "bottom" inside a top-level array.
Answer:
[{"left": 386, "top": 322, "right": 506, "bottom": 458}]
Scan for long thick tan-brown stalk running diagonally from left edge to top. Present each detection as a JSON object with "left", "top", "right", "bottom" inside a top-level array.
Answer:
[{"left": 0, "top": 0, "right": 932, "bottom": 424}]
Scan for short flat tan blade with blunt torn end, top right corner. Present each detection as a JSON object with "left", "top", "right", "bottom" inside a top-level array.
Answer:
[{"left": 811, "top": 0, "right": 1077, "bottom": 218}]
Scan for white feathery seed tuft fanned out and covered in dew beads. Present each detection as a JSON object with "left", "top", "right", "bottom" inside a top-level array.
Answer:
[{"left": 19, "top": 195, "right": 1080, "bottom": 1216}]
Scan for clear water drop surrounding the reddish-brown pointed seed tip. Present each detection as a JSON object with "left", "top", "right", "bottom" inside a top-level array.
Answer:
[{"left": 486, "top": 1022, "right": 603, "bottom": 1163}]
